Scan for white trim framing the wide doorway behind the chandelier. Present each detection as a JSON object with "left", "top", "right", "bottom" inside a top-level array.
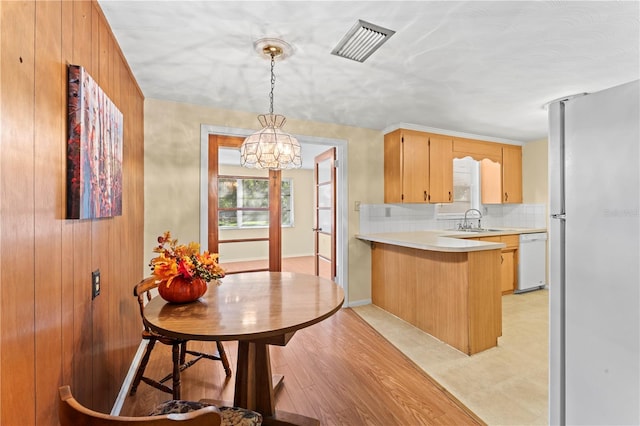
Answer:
[{"left": 200, "top": 124, "right": 349, "bottom": 306}]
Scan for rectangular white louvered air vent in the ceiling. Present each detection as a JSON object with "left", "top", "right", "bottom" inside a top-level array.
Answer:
[{"left": 331, "top": 19, "right": 395, "bottom": 62}]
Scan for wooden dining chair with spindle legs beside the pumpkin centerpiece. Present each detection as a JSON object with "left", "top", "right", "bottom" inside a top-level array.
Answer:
[{"left": 129, "top": 277, "right": 231, "bottom": 399}]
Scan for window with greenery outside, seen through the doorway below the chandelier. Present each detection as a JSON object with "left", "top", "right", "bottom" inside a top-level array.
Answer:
[{"left": 218, "top": 176, "right": 293, "bottom": 229}]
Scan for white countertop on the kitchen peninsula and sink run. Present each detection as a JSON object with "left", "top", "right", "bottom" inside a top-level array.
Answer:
[{"left": 356, "top": 228, "right": 547, "bottom": 252}]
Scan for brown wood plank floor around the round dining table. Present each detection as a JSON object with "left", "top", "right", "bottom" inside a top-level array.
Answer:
[{"left": 121, "top": 308, "right": 483, "bottom": 425}]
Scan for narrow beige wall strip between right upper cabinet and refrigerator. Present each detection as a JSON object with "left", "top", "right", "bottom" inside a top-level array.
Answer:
[{"left": 522, "top": 138, "right": 549, "bottom": 204}]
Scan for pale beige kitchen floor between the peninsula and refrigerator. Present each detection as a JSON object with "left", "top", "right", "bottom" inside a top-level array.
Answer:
[{"left": 219, "top": 257, "right": 549, "bottom": 426}]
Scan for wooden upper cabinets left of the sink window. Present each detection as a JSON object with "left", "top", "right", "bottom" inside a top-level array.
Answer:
[{"left": 384, "top": 129, "right": 453, "bottom": 203}]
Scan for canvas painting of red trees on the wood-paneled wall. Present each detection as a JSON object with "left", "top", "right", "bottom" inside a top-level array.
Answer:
[{"left": 67, "top": 65, "right": 123, "bottom": 219}]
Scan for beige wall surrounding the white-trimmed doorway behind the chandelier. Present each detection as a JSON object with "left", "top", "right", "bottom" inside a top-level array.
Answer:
[{"left": 144, "top": 99, "right": 383, "bottom": 302}]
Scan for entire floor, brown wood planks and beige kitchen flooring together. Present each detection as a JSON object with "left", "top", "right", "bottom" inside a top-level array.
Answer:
[{"left": 121, "top": 257, "right": 548, "bottom": 425}]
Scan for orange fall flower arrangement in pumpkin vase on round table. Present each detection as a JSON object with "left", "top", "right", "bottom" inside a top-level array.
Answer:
[{"left": 149, "top": 231, "right": 225, "bottom": 303}]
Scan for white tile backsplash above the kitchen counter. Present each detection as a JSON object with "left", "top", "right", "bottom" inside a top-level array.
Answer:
[{"left": 359, "top": 204, "right": 547, "bottom": 234}]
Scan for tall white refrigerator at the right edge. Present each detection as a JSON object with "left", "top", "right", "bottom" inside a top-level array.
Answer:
[{"left": 549, "top": 81, "right": 640, "bottom": 425}]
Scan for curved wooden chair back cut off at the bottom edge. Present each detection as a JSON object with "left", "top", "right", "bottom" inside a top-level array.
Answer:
[{"left": 58, "top": 386, "right": 222, "bottom": 426}]
